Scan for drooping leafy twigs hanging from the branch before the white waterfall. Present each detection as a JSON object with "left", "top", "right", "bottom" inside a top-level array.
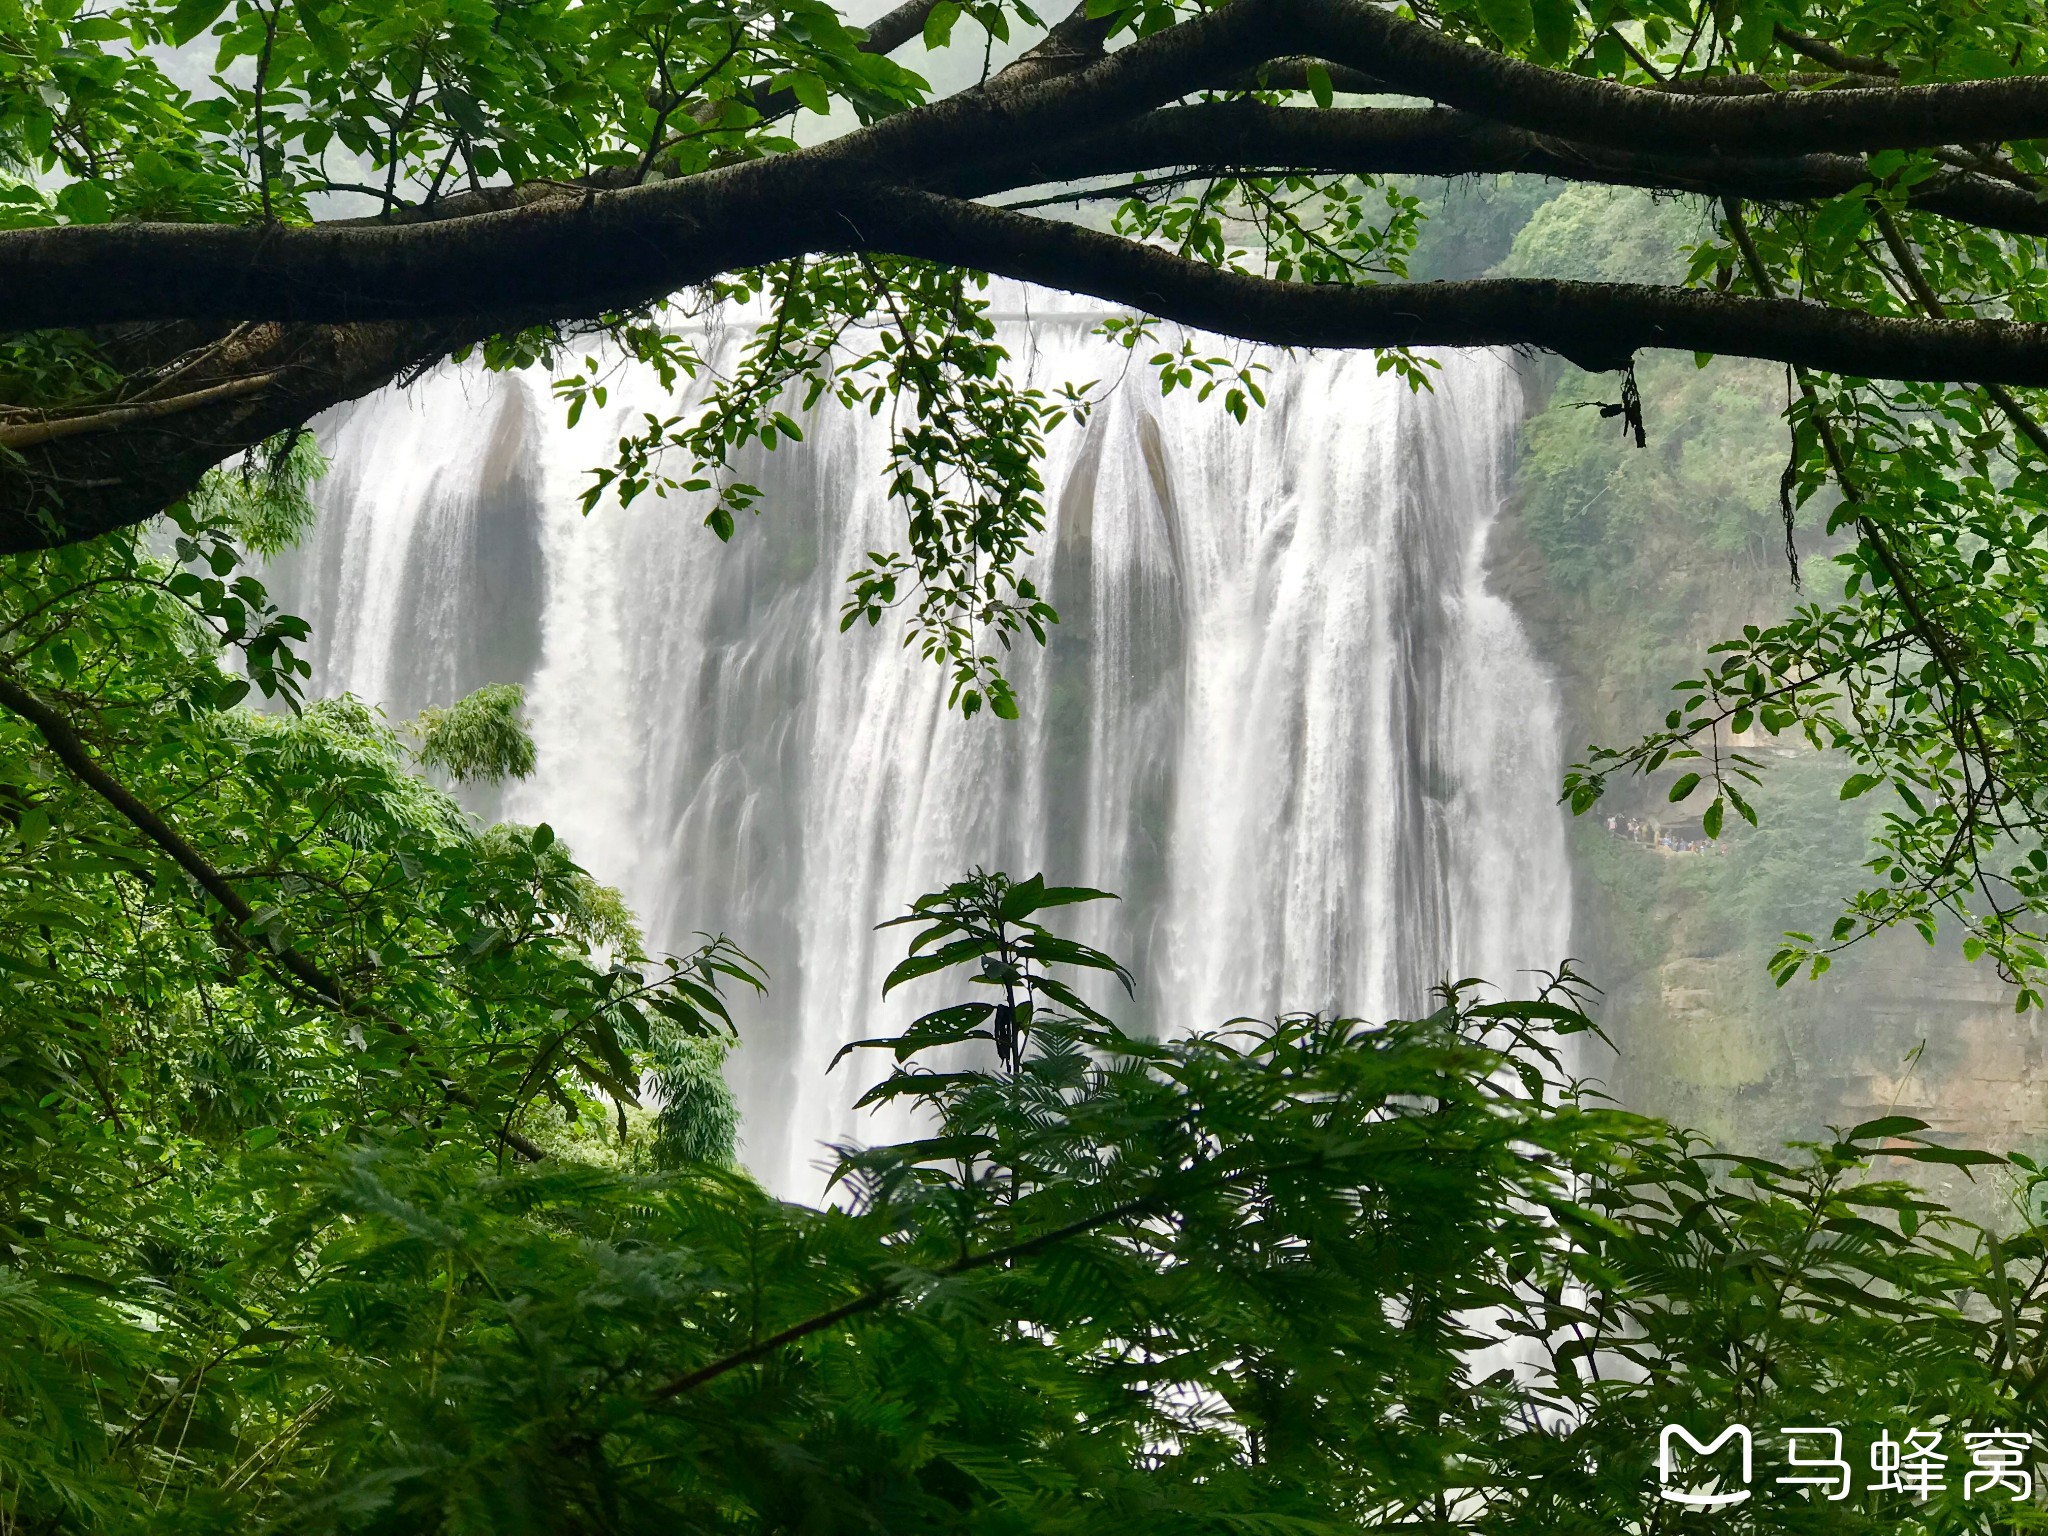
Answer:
[{"left": 555, "top": 258, "right": 1087, "bottom": 719}]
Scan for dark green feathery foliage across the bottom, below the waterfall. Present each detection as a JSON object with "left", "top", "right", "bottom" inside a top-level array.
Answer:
[{"left": 12, "top": 847, "right": 2048, "bottom": 1532}]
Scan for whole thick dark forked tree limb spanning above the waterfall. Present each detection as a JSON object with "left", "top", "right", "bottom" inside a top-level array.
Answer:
[{"left": 0, "top": 0, "right": 2048, "bottom": 551}]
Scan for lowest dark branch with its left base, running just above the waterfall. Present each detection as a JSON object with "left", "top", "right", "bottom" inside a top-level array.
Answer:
[{"left": 19, "top": 163, "right": 2048, "bottom": 551}]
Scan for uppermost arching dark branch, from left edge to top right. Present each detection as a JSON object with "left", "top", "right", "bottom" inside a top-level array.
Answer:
[{"left": 12, "top": 0, "right": 2048, "bottom": 328}]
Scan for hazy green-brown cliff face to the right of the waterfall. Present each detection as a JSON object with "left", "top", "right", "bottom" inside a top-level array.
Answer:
[{"left": 1491, "top": 205, "right": 2048, "bottom": 1214}]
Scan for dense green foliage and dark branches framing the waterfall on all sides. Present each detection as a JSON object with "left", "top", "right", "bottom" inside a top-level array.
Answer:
[{"left": 0, "top": 0, "right": 2048, "bottom": 1536}]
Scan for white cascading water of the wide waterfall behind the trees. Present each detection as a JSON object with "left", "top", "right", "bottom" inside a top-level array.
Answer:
[{"left": 274, "top": 293, "right": 1571, "bottom": 1194}]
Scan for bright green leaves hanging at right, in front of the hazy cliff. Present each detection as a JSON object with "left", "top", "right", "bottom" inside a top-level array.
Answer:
[{"left": 1523, "top": 60, "right": 2048, "bottom": 1010}]
